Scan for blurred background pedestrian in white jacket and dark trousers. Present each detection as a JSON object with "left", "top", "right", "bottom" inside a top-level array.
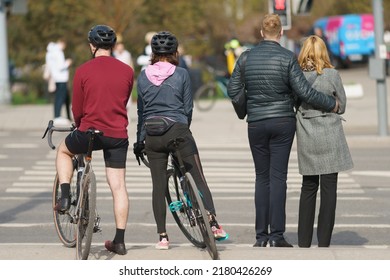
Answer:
[{"left": 45, "top": 39, "right": 72, "bottom": 122}]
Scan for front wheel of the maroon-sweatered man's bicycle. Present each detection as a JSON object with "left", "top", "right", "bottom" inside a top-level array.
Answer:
[{"left": 52, "top": 163, "right": 77, "bottom": 248}]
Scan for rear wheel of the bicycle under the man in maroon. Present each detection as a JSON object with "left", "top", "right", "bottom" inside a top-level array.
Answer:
[{"left": 76, "top": 170, "right": 96, "bottom": 260}]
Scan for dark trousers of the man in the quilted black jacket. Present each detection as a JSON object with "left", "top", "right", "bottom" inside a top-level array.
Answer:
[{"left": 248, "top": 118, "right": 296, "bottom": 241}]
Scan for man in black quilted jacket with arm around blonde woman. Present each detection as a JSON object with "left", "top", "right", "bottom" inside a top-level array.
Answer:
[{"left": 228, "top": 14, "right": 337, "bottom": 247}]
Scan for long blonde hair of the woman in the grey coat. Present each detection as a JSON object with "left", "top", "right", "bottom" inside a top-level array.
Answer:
[{"left": 298, "top": 35, "right": 334, "bottom": 74}]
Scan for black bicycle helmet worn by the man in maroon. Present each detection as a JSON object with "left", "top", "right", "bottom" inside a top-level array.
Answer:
[{"left": 88, "top": 25, "right": 116, "bottom": 49}]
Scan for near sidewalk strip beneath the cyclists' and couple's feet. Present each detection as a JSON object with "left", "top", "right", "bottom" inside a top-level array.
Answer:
[{"left": 0, "top": 243, "right": 390, "bottom": 260}]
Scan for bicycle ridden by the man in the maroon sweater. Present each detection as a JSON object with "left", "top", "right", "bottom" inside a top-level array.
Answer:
[{"left": 42, "top": 120, "right": 102, "bottom": 260}]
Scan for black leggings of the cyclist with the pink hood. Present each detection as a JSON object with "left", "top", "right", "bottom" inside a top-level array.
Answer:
[{"left": 145, "top": 123, "right": 215, "bottom": 233}]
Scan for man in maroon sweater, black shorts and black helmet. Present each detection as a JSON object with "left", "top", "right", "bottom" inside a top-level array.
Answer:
[{"left": 55, "top": 25, "right": 134, "bottom": 255}]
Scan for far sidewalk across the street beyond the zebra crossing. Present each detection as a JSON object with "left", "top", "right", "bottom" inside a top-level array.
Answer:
[{"left": 0, "top": 98, "right": 390, "bottom": 150}]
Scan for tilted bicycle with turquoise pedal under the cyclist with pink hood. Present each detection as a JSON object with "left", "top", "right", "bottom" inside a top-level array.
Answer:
[{"left": 139, "top": 137, "right": 219, "bottom": 260}]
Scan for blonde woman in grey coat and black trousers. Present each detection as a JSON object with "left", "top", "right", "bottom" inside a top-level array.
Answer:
[{"left": 296, "top": 35, "right": 353, "bottom": 247}]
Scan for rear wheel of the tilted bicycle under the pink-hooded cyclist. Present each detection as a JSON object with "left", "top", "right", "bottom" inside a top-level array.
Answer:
[{"left": 185, "top": 172, "right": 219, "bottom": 260}]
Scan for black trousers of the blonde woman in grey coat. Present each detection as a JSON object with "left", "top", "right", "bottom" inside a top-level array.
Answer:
[{"left": 298, "top": 173, "right": 338, "bottom": 247}]
